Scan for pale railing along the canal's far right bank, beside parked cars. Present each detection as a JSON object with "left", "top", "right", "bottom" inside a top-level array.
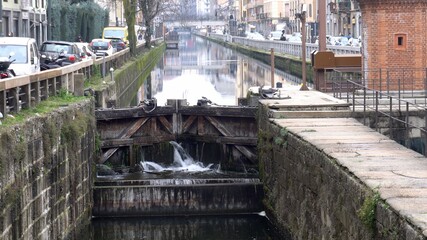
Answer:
[{"left": 208, "top": 33, "right": 360, "bottom": 60}]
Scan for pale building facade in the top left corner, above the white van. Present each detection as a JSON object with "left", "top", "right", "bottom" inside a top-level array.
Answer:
[{"left": 0, "top": 0, "right": 49, "bottom": 45}]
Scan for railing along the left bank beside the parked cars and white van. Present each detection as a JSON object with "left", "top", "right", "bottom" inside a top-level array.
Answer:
[{"left": 0, "top": 39, "right": 162, "bottom": 117}]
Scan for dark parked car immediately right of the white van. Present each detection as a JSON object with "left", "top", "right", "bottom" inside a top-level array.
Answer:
[{"left": 40, "top": 41, "right": 82, "bottom": 66}]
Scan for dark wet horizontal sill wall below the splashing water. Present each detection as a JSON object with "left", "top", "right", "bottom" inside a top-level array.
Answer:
[{"left": 93, "top": 178, "right": 263, "bottom": 217}]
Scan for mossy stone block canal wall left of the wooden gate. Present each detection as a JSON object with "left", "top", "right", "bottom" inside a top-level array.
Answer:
[{"left": 0, "top": 100, "right": 95, "bottom": 240}]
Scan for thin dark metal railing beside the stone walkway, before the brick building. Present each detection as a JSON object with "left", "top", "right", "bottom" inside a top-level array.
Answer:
[{"left": 326, "top": 68, "right": 427, "bottom": 156}]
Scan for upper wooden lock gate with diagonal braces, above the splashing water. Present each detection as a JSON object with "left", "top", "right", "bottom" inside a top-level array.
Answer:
[{"left": 95, "top": 100, "right": 258, "bottom": 169}]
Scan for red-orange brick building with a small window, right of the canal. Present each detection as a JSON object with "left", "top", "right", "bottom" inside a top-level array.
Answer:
[{"left": 358, "top": 0, "right": 427, "bottom": 90}]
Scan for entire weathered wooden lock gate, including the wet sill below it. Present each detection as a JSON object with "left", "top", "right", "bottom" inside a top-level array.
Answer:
[{"left": 93, "top": 100, "right": 263, "bottom": 217}]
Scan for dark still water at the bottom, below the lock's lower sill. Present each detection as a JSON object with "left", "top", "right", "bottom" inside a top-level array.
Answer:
[{"left": 92, "top": 215, "right": 290, "bottom": 240}]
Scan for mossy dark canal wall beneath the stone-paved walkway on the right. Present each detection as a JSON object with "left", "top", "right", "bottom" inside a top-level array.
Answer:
[{"left": 258, "top": 105, "right": 423, "bottom": 239}]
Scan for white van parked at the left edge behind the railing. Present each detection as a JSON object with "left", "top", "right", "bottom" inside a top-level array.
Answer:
[{"left": 0, "top": 37, "right": 40, "bottom": 76}]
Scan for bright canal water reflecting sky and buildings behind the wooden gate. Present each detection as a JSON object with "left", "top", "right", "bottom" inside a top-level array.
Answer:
[{"left": 138, "top": 35, "right": 300, "bottom": 106}]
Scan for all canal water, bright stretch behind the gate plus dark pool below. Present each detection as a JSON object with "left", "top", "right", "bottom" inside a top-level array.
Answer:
[{"left": 82, "top": 35, "right": 300, "bottom": 240}]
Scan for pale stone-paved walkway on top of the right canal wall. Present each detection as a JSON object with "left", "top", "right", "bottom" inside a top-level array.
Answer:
[{"left": 261, "top": 90, "right": 427, "bottom": 237}]
